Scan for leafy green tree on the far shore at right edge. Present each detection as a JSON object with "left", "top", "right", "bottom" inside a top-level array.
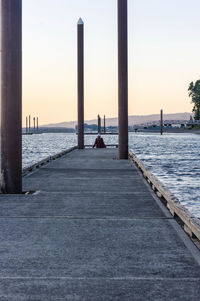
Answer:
[{"left": 188, "top": 80, "right": 200, "bottom": 120}]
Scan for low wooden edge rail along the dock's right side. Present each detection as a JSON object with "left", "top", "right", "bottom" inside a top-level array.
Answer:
[{"left": 129, "top": 150, "right": 200, "bottom": 241}]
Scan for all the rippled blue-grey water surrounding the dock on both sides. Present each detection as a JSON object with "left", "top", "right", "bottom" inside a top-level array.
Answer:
[{"left": 23, "top": 133, "right": 200, "bottom": 218}]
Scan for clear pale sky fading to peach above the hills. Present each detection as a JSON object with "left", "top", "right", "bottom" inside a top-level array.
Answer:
[{"left": 23, "top": 0, "right": 200, "bottom": 124}]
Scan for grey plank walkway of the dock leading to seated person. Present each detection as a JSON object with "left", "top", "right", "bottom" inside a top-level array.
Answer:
[{"left": 0, "top": 149, "right": 200, "bottom": 301}]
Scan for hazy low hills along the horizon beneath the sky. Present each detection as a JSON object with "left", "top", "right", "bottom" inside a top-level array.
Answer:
[{"left": 42, "top": 112, "right": 192, "bottom": 128}]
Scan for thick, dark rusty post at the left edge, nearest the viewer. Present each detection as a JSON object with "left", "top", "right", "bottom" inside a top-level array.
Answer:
[{"left": 0, "top": 0, "right": 22, "bottom": 193}]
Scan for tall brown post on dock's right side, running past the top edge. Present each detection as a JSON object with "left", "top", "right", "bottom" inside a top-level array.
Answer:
[{"left": 118, "top": 0, "right": 128, "bottom": 159}]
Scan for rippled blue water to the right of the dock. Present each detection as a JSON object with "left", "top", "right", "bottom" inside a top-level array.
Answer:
[{"left": 130, "top": 134, "right": 200, "bottom": 217}]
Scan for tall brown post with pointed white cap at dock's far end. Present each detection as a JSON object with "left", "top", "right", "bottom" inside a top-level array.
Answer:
[{"left": 77, "top": 18, "right": 84, "bottom": 149}]
